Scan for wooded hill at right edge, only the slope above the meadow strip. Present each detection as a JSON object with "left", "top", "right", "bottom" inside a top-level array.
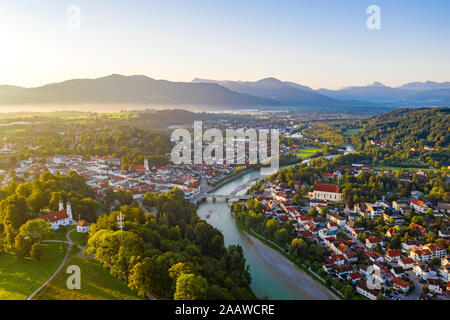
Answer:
[{"left": 361, "top": 108, "right": 450, "bottom": 151}]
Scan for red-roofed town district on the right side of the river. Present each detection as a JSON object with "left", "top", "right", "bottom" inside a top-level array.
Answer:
[{"left": 235, "top": 163, "right": 450, "bottom": 300}]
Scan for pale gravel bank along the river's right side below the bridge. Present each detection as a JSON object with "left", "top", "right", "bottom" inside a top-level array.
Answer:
[{"left": 236, "top": 220, "right": 341, "bottom": 300}]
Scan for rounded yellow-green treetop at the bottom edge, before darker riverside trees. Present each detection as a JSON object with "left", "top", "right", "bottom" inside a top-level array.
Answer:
[{"left": 173, "top": 273, "right": 208, "bottom": 300}]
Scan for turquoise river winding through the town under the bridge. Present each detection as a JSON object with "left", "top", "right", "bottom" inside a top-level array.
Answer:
[{"left": 197, "top": 145, "right": 355, "bottom": 300}]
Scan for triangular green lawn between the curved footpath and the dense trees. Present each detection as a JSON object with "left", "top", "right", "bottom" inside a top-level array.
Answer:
[{"left": 34, "top": 256, "right": 141, "bottom": 300}]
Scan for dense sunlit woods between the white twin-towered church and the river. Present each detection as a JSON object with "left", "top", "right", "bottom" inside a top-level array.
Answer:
[{"left": 87, "top": 189, "right": 256, "bottom": 300}]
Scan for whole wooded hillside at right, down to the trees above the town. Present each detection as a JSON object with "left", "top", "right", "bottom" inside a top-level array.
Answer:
[{"left": 354, "top": 108, "right": 450, "bottom": 168}]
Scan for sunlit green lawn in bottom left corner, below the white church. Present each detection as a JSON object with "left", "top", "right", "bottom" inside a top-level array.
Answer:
[{"left": 0, "top": 243, "right": 67, "bottom": 300}]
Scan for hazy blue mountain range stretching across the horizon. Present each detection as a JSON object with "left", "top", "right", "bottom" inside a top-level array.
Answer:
[{"left": 0, "top": 74, "right": 450, "bottom": 110}]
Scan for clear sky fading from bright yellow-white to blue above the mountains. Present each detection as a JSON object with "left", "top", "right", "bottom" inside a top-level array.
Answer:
[{"left": 0, "top": 0, "right": 450, "bottom": 89}]
